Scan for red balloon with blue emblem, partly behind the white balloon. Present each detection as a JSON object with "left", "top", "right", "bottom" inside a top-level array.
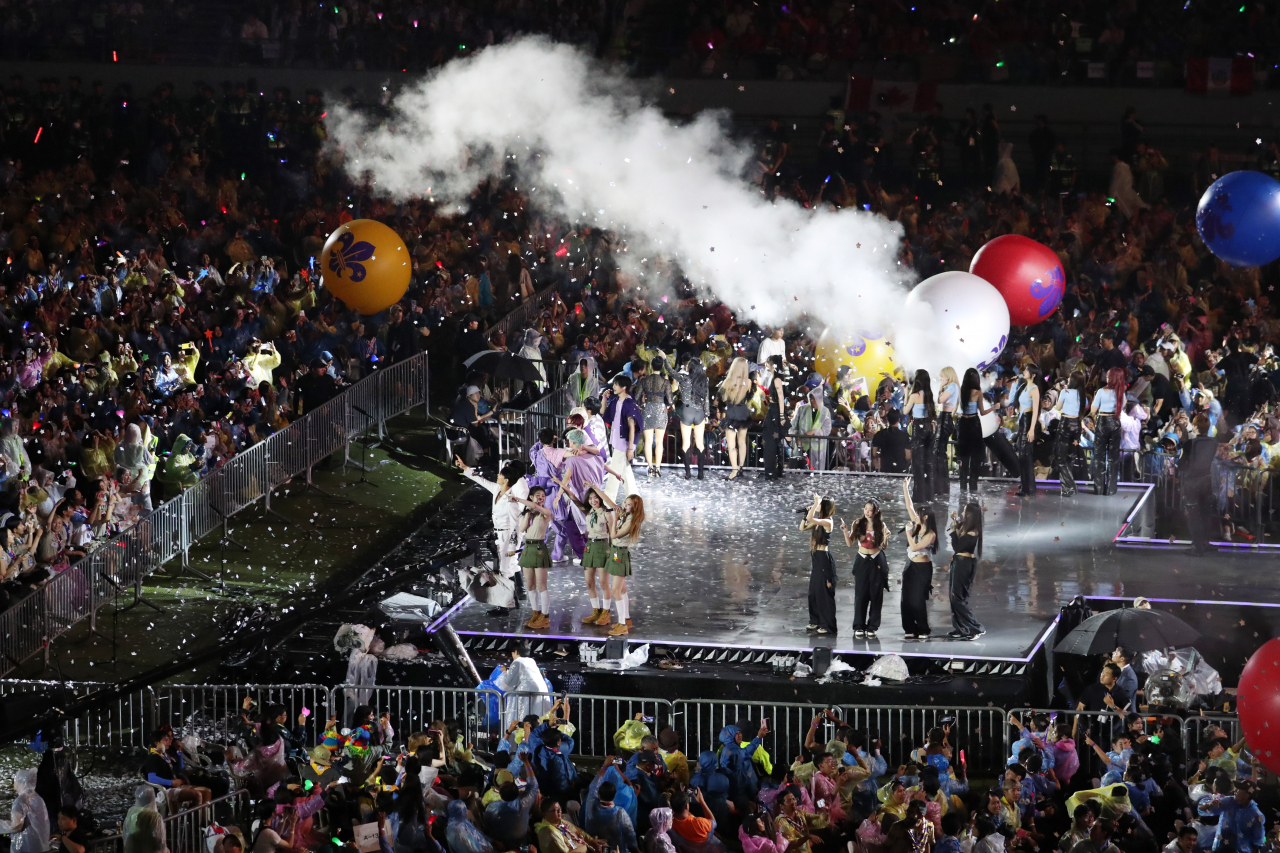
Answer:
[{"left": 969, "top": 234, "right": 1066, "bottom": 325}]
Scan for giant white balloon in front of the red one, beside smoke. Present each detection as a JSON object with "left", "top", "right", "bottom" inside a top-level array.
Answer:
[{"left": 904, "top": 272, "right": 1009, "bottom": 373}]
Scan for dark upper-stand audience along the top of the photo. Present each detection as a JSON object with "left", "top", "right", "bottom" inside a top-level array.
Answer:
[{"left": 0, "top": 0, "right": 1280, "bottom": 86}]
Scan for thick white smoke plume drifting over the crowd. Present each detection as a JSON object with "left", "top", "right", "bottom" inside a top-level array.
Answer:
[{"left": 329, "top": 38, "right": 911, "bottom": 343}]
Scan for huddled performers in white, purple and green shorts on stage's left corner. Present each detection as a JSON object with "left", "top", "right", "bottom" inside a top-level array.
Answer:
[{"left": 457, "top": 374, "right": 644, "bottom": 637}]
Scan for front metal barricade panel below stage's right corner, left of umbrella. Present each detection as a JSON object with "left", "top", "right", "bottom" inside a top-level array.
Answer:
[{"left": 841, "top": 706, "right": 1010, "bottom": 774}]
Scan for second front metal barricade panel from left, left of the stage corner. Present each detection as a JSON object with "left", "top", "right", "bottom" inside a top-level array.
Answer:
[{"left": 154, "top": 684, "right": 333, "bottom": 745}]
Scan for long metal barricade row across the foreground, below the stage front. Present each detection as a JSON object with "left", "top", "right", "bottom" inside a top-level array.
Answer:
[{"left": 0, "top": 680, "right": 1240, "bottom": 778}]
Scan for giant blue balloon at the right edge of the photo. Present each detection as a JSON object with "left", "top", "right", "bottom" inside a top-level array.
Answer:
[{"left": 1196, "top": 172, "right": 1280, "bottom": 266}]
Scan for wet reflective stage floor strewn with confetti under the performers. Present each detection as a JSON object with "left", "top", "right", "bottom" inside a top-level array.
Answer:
[{"left": 453, "top": 469, "right": 1259, "bottom": 661}]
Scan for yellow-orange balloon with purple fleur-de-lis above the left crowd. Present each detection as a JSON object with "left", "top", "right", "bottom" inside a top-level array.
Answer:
[{"left": 320, "top": 219, "right": 413, "bottom": 314}]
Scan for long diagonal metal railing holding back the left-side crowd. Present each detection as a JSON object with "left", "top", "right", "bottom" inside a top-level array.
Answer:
[{"left": 0, "top": 353, "right": 429, "bottom": 675}]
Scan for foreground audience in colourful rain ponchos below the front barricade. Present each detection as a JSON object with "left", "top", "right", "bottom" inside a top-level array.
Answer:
[{"left": 27, "top": 676, "right": 1276, "bottom": 853}]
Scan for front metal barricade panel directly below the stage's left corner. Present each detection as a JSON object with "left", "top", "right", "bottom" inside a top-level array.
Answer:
[{"left": 330, "top": 684, "right": 506, "bottom": 752}]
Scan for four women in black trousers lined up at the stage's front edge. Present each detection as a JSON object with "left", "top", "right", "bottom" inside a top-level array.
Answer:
[{"left": 800, "top": 480, "right": 986, "bottom": 640}]
